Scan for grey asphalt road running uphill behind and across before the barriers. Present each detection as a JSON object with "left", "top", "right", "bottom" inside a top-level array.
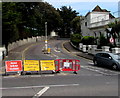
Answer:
[{"left": 0, "top": 40, "right": 120, "bottom": 98}]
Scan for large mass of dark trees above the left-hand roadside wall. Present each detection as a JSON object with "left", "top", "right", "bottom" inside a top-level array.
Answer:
[{"left": 2, "top": 2, "right": 61, "bottom": 46}]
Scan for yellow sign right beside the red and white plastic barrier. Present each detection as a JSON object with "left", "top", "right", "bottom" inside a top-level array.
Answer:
[{"left": 40, "top": 60, "right": 55, "bottom": 71}]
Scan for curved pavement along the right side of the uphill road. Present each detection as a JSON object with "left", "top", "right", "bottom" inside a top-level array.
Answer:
[{"left": 63, "top": 42, "right": 93, "bottom": 60}]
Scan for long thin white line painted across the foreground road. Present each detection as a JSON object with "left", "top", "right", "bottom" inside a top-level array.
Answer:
[{"left": 0, "top": 84, "right": 79, "bottom": 90}]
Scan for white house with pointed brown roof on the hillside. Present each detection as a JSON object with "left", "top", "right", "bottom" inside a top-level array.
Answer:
[{"left": 81, "top": 5, "right": 115, "bottom": 37}]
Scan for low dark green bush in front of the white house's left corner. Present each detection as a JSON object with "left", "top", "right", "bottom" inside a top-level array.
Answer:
[{"left": 81, "top": 36, "right": 96, "bottom": 45}]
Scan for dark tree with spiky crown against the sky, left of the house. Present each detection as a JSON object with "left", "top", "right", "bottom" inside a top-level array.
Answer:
[{"left": 57, "top": 6, "right": 78, "bottom": 37}]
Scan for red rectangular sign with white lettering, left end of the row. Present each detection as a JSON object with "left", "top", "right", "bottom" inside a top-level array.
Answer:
[{"left": 5, "top": 60, "right": 22, "bottom": 72}]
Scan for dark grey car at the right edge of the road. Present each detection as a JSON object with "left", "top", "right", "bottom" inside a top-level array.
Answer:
[{"left": 93, "top": 52, "right": 120, "bottom": 70}]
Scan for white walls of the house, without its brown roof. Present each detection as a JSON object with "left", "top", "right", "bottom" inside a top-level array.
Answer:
[{"left": 81, "top": 12, "right": 111, "bottom": 36}]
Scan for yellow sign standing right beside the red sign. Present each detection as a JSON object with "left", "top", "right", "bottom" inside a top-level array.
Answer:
[{"left": 24, "top": 60, "right": 40, "bottom": 71}]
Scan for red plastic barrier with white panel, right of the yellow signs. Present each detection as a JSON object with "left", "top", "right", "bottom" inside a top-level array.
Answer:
[{"left": 55, "top": 59, "right": 80, "bottom": 73}]
